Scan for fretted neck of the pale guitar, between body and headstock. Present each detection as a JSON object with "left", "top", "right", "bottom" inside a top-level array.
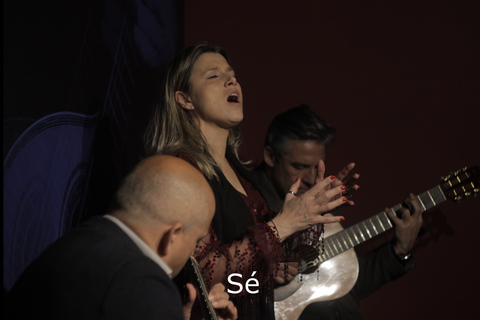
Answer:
[{"left": 319, "top": 185, "right": 447, "bottom": 263}]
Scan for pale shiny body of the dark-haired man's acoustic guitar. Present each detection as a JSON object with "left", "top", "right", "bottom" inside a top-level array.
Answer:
[{"left": 275, "top": 216, "right": 359, "bottom": 320}]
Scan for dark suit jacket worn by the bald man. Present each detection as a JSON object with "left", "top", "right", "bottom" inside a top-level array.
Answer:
[{"left": 5, "top": 217, "right": 183, "bottom": 320}]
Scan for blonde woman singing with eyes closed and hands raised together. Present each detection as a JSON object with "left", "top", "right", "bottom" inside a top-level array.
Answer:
[{"left": 146, "top": 44, "right": 353, "bottom": 320}]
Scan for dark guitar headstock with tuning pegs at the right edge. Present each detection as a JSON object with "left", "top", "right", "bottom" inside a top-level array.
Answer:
[{"left": 440, "top": 165, "right": 480, "bottom": 202}]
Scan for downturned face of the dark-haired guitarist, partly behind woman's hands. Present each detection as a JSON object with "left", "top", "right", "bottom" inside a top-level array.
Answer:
[{"left": 265, "top": 140, "right": 325, "bottom": 199}]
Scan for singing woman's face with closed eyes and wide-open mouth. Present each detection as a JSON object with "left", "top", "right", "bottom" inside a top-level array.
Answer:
[{"left": 187, "top": 53, "right": 243, "bottom": 133}]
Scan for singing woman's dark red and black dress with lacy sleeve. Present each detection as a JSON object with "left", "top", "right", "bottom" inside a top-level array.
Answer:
[{"left": 174, "top": 154, "right": 282, "bottom": 319}]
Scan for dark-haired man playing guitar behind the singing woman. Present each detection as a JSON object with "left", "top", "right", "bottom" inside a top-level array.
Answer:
[{"left": 254, "top": 105, "right": 422, "bottom": 320}]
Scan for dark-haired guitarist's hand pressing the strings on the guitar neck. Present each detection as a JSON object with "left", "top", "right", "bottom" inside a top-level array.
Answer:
[{"left": 385, "top": 194, "right": 423, "bottom": 256}]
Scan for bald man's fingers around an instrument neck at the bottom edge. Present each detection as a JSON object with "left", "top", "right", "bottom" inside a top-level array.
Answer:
[{"left": 183, "top": 283, "right": 238, "bottom": 320}]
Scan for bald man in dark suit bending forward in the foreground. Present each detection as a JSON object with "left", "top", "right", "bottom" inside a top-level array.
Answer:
[{"left": 6, "top": 156, "right": 237, "bottom": 320}]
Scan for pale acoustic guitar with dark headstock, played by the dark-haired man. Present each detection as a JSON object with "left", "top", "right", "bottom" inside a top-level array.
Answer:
[{"left": 275, "top": 166, "right": 480, "bottom": 320}]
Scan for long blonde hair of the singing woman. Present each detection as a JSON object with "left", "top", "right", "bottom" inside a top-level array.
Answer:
[{"left": 144, "top": 44, "right": 242, "bottom": 179}]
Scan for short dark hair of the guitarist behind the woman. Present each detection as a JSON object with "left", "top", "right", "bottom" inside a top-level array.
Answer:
[{"left": 265, "top": 104, "right": 335, "bottom": 158}]
